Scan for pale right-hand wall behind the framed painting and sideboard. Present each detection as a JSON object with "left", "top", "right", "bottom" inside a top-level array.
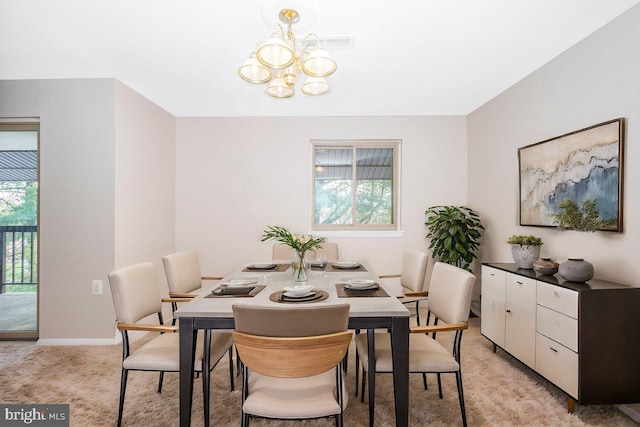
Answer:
[{"left": 468, "top": 2, "right": 640, "bottom": 286}]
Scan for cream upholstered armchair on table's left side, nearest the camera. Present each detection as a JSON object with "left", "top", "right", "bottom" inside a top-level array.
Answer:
[{"left": 109, "top": 262, "right": 233, "bottom": 426}]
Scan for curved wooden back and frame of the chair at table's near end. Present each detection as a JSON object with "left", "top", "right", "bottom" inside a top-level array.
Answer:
[{"left": 232, "top": 331, "right": 353, "bottom": 427}]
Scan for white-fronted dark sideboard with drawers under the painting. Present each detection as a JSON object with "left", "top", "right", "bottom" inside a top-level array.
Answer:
[{"left": 480, "top": 263, "right": 640, "bottom": 412}]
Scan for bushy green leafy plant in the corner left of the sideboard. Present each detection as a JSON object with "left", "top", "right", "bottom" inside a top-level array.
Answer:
[{"left": 425, "top": 206, "right": 484, "bottom": 271}]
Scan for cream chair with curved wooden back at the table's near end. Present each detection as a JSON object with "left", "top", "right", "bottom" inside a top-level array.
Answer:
[{"left": 233, "top": 304, "right": 352, "bottom": 427}]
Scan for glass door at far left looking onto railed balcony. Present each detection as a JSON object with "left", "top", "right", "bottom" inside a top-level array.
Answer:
[{"left": 0, "top": 122, "right": 39, "bottom": 339}]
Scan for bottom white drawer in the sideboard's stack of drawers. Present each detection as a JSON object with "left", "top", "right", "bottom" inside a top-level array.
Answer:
[{"left": 536, "top": 334, "right": 580, "bottom": 399}]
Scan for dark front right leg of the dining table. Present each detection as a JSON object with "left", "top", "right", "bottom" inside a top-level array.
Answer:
[{"left": 391, "top": 317, "right": 409, "bottom": 427}]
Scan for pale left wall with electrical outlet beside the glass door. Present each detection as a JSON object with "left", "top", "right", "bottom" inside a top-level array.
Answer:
[{"left": 0, "top": 79, "right": 115, "bottom": 339}]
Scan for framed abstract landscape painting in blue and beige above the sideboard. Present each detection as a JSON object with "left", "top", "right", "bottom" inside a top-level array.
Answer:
[{"left": 518, "top": 118, "right": 624, "bottom": 232}]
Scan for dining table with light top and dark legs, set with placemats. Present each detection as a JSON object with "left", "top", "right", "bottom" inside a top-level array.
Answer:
[{"left": 175, "top": 261, "right": 409, "bottom": 427}]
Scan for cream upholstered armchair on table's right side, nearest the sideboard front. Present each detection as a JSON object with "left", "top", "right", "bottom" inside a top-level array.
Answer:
[{"left": 355, "top": 262, "right": 476, "bottom": 427}]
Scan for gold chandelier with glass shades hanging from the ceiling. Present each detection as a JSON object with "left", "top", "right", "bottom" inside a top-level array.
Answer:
[{"left": 238, "top": 8, "right": 338, "bottom": 98}]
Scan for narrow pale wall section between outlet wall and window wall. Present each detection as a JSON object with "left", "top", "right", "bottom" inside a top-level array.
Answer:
[{"left": 115, "top": 82, "right": 176, "bottom": 294}]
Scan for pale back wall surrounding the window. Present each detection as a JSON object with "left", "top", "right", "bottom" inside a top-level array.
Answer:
[{"left": 176, "top": 117, "right": 467, "bottom": 275}]
